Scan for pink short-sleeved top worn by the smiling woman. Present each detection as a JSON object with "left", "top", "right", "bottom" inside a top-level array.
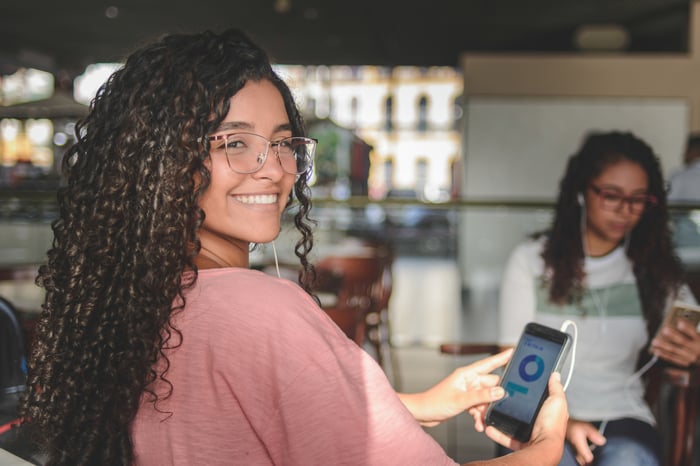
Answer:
[{"left": 132, "top": 268, "right": 455, "bottom": 466}]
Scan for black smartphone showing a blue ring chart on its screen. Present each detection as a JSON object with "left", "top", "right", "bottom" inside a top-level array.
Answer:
[{"left": 485, "top": 322, "right": 571, "bottom": 442}]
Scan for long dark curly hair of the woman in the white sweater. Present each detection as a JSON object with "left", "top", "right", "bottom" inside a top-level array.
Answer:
[{"left": 542, "top": 131, "right": 683, "bottom": 337}]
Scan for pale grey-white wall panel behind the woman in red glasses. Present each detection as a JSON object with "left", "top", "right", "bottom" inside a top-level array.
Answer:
[{"left": 462, "top": 97, "right": 689, "bottom": 199}]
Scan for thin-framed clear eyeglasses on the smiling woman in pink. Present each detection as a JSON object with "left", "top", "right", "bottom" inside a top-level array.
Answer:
[{"left": 209, "top": 133, "right": 318, "bottom": 175}]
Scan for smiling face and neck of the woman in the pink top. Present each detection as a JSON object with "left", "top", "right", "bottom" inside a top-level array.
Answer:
[{"left": 197, "top": 80, "right": 295, "bottom": 268}]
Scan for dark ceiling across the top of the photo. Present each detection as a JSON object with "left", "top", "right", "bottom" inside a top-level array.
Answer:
[{"left": 0, "top": 0, "right": 689, "bottom": 76}]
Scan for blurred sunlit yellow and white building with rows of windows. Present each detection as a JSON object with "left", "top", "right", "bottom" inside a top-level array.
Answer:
[{"left": 278, "top": 66, "right": 463, "bottom": 202}]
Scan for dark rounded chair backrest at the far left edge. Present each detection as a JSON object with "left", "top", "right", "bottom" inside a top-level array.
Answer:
[{"left": 0, "top": 297, "right": 27, "bottom": 423}]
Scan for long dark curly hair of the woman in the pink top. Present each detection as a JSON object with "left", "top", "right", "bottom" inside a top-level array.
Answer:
[{"left": 22, "top": 30, "right": 313, "bottom": 465}]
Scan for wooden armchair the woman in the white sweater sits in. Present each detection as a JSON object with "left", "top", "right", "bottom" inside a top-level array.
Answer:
[{"left": 440, "top": 343, "right": 700, "bottom": 466}]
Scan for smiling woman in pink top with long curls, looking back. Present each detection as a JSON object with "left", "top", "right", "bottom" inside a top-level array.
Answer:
[{"left": 24, "top": 31, "right": 567, "bottom": 465}]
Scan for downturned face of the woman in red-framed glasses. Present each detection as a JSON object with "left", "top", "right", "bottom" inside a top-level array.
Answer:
[{"left": 586, "top": 159, "right": 649, "bottom": 256}]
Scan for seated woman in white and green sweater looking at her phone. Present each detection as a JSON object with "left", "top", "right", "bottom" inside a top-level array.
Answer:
[{"left": 500, "top": 132, "right": 700, "bottom": 466}]
